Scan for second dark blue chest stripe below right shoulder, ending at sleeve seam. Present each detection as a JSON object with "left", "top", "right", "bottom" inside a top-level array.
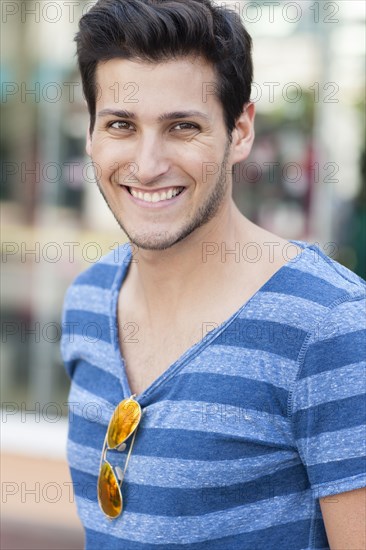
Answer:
[{"left": 212, "top": 318, "right": 306, "bottom": 360}]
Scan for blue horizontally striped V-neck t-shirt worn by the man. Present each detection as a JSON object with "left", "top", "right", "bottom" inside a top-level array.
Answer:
[{"left": 62, "top": 242, "right": 366, "bottom": 550}]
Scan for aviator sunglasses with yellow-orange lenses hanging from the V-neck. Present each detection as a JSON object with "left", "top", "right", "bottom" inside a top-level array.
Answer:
[{"left": 98, "top": 394, "right": 142, "bottom": 519}]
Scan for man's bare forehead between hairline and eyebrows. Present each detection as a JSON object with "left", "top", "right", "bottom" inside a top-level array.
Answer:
[{"left": 96, "top": 57, "right": 221, "bottom": 112}]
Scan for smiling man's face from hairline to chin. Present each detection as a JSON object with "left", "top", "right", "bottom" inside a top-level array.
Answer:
[{"left": 87, "top": 58, "right": 243, "bottom": 250}]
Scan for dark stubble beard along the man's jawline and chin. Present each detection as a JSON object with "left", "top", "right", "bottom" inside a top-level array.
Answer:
[{"left": 95, "top": 140, "right": 230, "bottom": 250}]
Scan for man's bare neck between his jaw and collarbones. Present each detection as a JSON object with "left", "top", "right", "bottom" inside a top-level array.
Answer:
[{"left": 124, "top": 201, "right": 253, "bottom": 316}]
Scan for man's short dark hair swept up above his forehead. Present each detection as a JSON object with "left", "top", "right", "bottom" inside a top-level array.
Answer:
[{"left": 75, "top": 0, "right": 253, "bottom": 137}]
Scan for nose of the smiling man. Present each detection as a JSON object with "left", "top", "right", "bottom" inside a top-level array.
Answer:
[{"left": 129, "top": 134, "right": 170, "bottom": 186}]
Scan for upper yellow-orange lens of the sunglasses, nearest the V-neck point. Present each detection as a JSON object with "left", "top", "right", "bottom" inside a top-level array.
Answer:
[{"left": 107, "top": 399, "right": 141, "bottom": 449}]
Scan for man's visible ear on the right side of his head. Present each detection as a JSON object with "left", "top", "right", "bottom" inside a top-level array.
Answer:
[{"left": 231, "top": 103, "right": 255, "bottom": 164}]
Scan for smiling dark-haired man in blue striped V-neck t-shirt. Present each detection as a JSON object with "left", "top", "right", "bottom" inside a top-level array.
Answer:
[{"left": 62, "top": 0, "right": 365, "bottom": 550}]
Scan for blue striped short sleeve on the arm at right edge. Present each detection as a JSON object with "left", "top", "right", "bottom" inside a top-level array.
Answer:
[{"left": 291, "top": 296, "right": 366, "bottom": 498}]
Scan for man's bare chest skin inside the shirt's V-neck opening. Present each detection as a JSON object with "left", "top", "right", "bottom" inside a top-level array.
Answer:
[{"left": 118, "top": 244, "right": 298, "bottom": 395}]
